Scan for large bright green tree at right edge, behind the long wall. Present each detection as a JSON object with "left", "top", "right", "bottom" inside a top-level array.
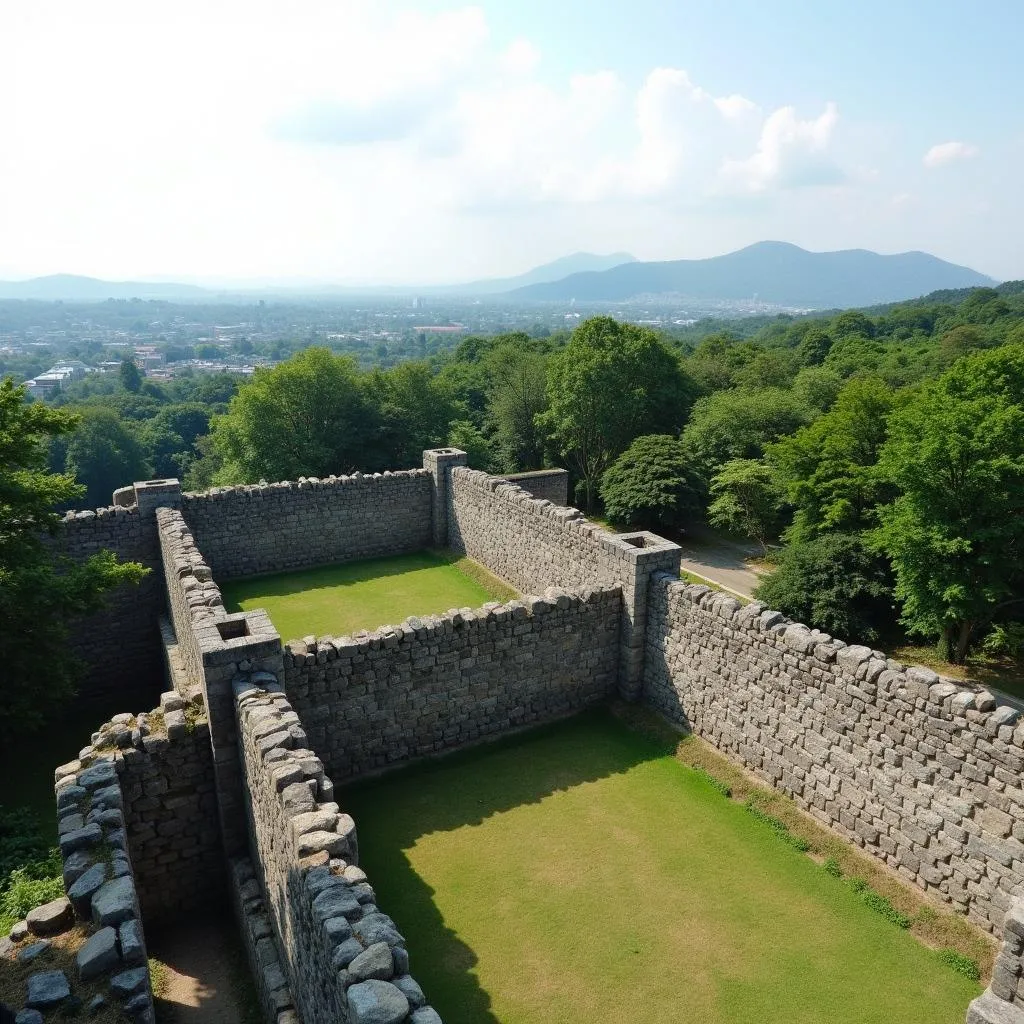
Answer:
[{"left": 873, "top": 346, "right": 1024, "bottom": 664}]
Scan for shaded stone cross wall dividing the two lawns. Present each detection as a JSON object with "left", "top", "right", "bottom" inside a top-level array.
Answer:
[{"left": 285, "top": 589, "right": 621, "bottom": 781}]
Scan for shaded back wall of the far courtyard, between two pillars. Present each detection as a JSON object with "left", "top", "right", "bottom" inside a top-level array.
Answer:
[{"left": 182, "top": 470, "right": 431, "bottom": 582}]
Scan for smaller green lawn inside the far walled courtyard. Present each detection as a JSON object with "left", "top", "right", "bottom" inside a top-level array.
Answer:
[{"left": 220, "top": 551, "right": 514, "bottom": 640}]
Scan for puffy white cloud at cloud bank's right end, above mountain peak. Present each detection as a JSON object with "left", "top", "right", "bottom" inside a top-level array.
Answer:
[{"left": 722, "top": 103, "right": 844, "bottom": 193}]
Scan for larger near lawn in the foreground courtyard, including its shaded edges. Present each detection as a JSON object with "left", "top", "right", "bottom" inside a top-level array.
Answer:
[{"left": 340, "top": 713, "right": 980, "bottom": 1024}]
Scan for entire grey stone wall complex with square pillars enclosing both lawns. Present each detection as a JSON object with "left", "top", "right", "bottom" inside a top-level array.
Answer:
[{"left": 54, "top": 449, "right": 1024, "bottom": 1024}]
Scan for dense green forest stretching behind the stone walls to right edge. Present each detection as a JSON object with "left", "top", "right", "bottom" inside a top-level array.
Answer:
[{"left": 28, "top": 282, "right": 1024, "bottom": 664}]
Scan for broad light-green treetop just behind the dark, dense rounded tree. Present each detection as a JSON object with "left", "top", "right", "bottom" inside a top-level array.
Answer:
[{"left": 683, "top": 388, "right": 813, "bottom": 480}]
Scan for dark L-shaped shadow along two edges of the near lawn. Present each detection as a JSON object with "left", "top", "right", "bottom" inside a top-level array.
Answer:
[{"left": 338, "top": 708, "right": 674, "bottom": 1024}]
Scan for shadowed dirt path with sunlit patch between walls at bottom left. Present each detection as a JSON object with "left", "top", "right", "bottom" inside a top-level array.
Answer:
[{"left": 148, "top": 919, "right": 246, "bottom": 1024}]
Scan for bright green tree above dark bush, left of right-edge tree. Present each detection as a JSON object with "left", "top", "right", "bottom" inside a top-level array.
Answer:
[{"left": 768, "top": 377, "right": 894, "bottom": 543}]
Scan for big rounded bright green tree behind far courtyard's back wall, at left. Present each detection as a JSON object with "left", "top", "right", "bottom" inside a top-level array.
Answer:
[{"left": 211, "top": 348, "right": 376, "bottom": 483}]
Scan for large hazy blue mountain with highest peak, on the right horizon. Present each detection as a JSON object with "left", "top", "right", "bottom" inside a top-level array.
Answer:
[{"left": 503, "top": 242, "right": 995, "bottom": 309}]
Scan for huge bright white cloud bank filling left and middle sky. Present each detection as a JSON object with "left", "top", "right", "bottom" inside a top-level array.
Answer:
[{"left": 0, "top": 0, "right": 840, "bottom": 281}]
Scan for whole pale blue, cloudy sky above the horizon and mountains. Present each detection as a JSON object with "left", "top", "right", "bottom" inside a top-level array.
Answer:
[{"left": 0, "top": 0, "right": 1024, "bottom": 284}]
